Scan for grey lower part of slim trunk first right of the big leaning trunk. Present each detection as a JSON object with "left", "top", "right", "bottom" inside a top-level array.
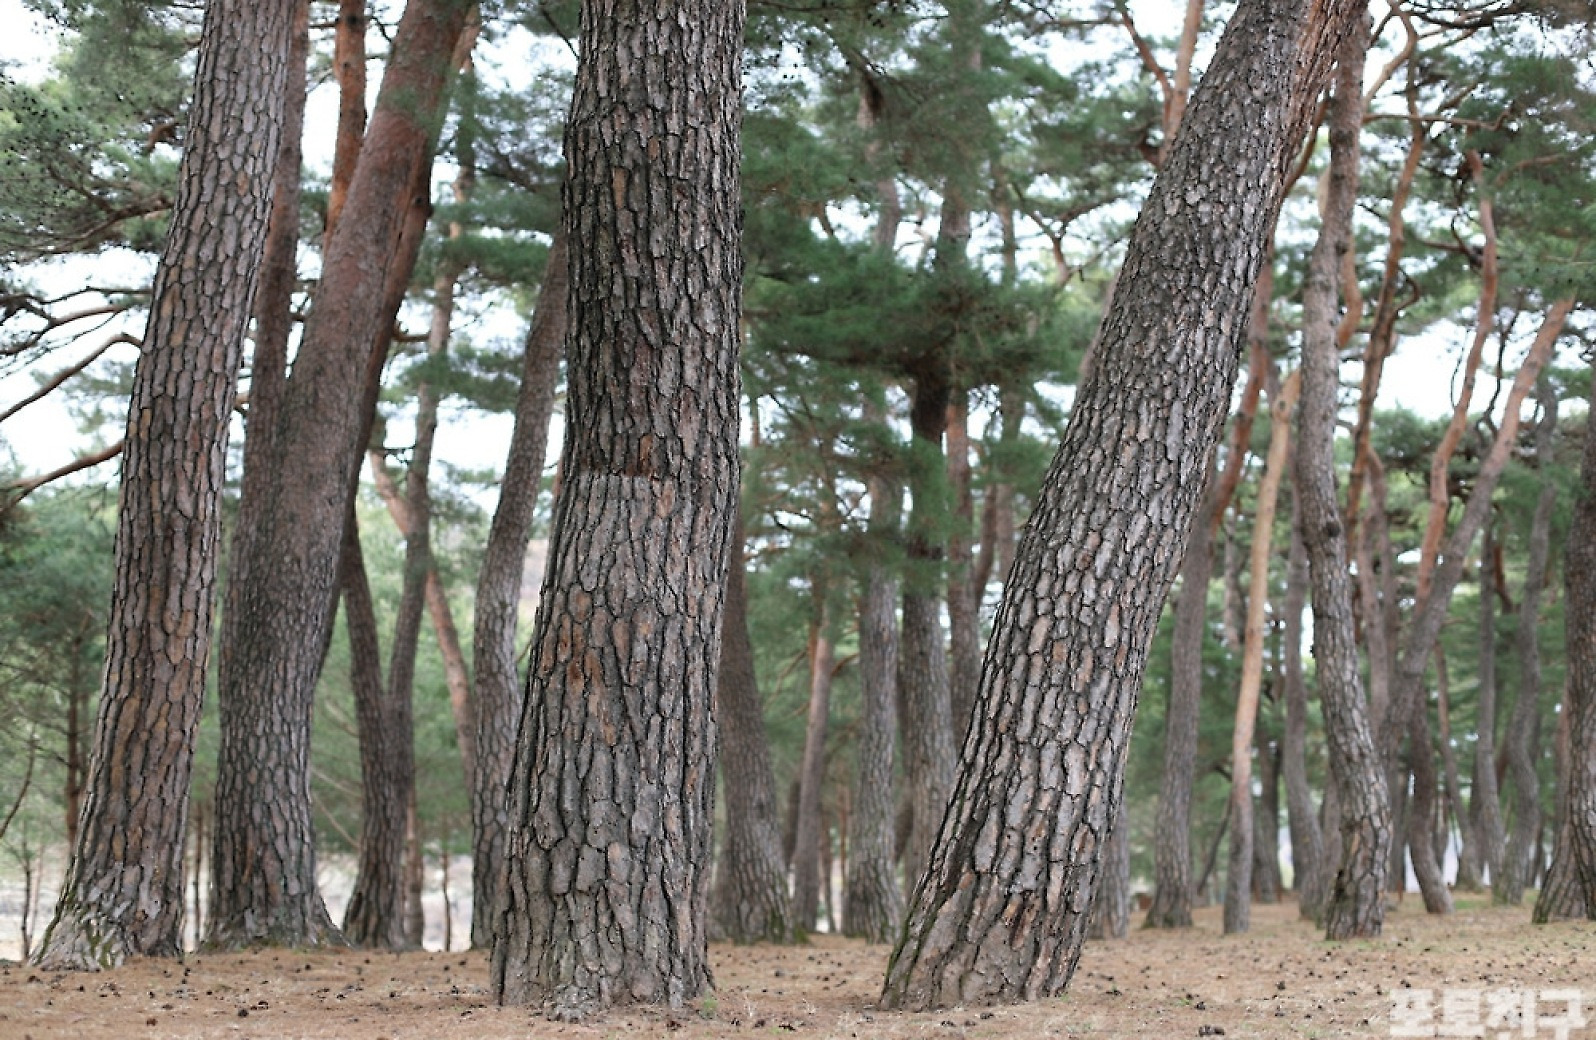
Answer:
[{"left": 1148, "top": 466, "right": 1219, "bottom": 928}]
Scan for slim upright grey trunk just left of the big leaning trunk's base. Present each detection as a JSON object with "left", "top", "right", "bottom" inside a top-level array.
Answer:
[{"left": 843, "top": 520, "right": 903, "bottom": 943}]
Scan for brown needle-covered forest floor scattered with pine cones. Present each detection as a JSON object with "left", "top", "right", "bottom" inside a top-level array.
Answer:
[{"left": 0, "top": 895, "right": 1596, "bottom": 1040}]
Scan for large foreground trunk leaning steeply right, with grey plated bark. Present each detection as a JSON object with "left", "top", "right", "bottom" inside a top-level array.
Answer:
[{"left": 881, "top": 3, "right": 1353, "bottom": 1008}]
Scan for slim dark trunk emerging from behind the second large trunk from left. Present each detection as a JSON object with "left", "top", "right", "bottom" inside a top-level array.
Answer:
[{"left": 338, "top": 509, "right": 415, "bottom": 949}]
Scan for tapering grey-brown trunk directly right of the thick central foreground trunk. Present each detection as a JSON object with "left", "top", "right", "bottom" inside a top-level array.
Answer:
[{"left": 713, "top": 523, "right": 791, "bottom": 943}]
